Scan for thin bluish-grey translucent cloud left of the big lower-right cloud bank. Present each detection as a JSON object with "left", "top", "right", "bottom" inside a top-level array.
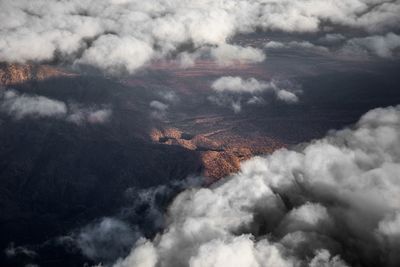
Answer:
[{"left": 54, "top": 176, "right": 205, "bottom": 266}]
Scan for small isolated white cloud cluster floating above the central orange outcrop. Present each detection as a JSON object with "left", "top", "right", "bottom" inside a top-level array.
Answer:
[{"left": 209, "top": 76, "right": 299, "bottom": 113}]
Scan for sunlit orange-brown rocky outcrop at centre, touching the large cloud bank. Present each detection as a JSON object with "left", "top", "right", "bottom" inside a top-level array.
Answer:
[{"left": 150, "top": 127, "right": 284, "bottom": 183}]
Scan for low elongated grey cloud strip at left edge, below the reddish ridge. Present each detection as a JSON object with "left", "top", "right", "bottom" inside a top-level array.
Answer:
[{"left": 0, "top": 89, "right": 112, "bottom": 124}]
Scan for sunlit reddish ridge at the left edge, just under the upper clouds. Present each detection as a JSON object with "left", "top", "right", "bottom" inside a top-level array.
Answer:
[{"left": 0, "top": 63, "right": 74, "bottom": 86}]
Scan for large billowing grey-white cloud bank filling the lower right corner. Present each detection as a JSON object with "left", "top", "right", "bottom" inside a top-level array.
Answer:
[{"left": 114, "top": 106, "right": 400, "bottom": 267}]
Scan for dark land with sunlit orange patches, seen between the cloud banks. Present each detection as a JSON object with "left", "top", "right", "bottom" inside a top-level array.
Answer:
[{"left": 0, "top": 59, "right": 400, "bottom": 266}]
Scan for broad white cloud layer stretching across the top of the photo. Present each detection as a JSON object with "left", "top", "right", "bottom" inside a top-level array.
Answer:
[{"left": 0, "top": 0, "right": 400, "bottom": 73}]
